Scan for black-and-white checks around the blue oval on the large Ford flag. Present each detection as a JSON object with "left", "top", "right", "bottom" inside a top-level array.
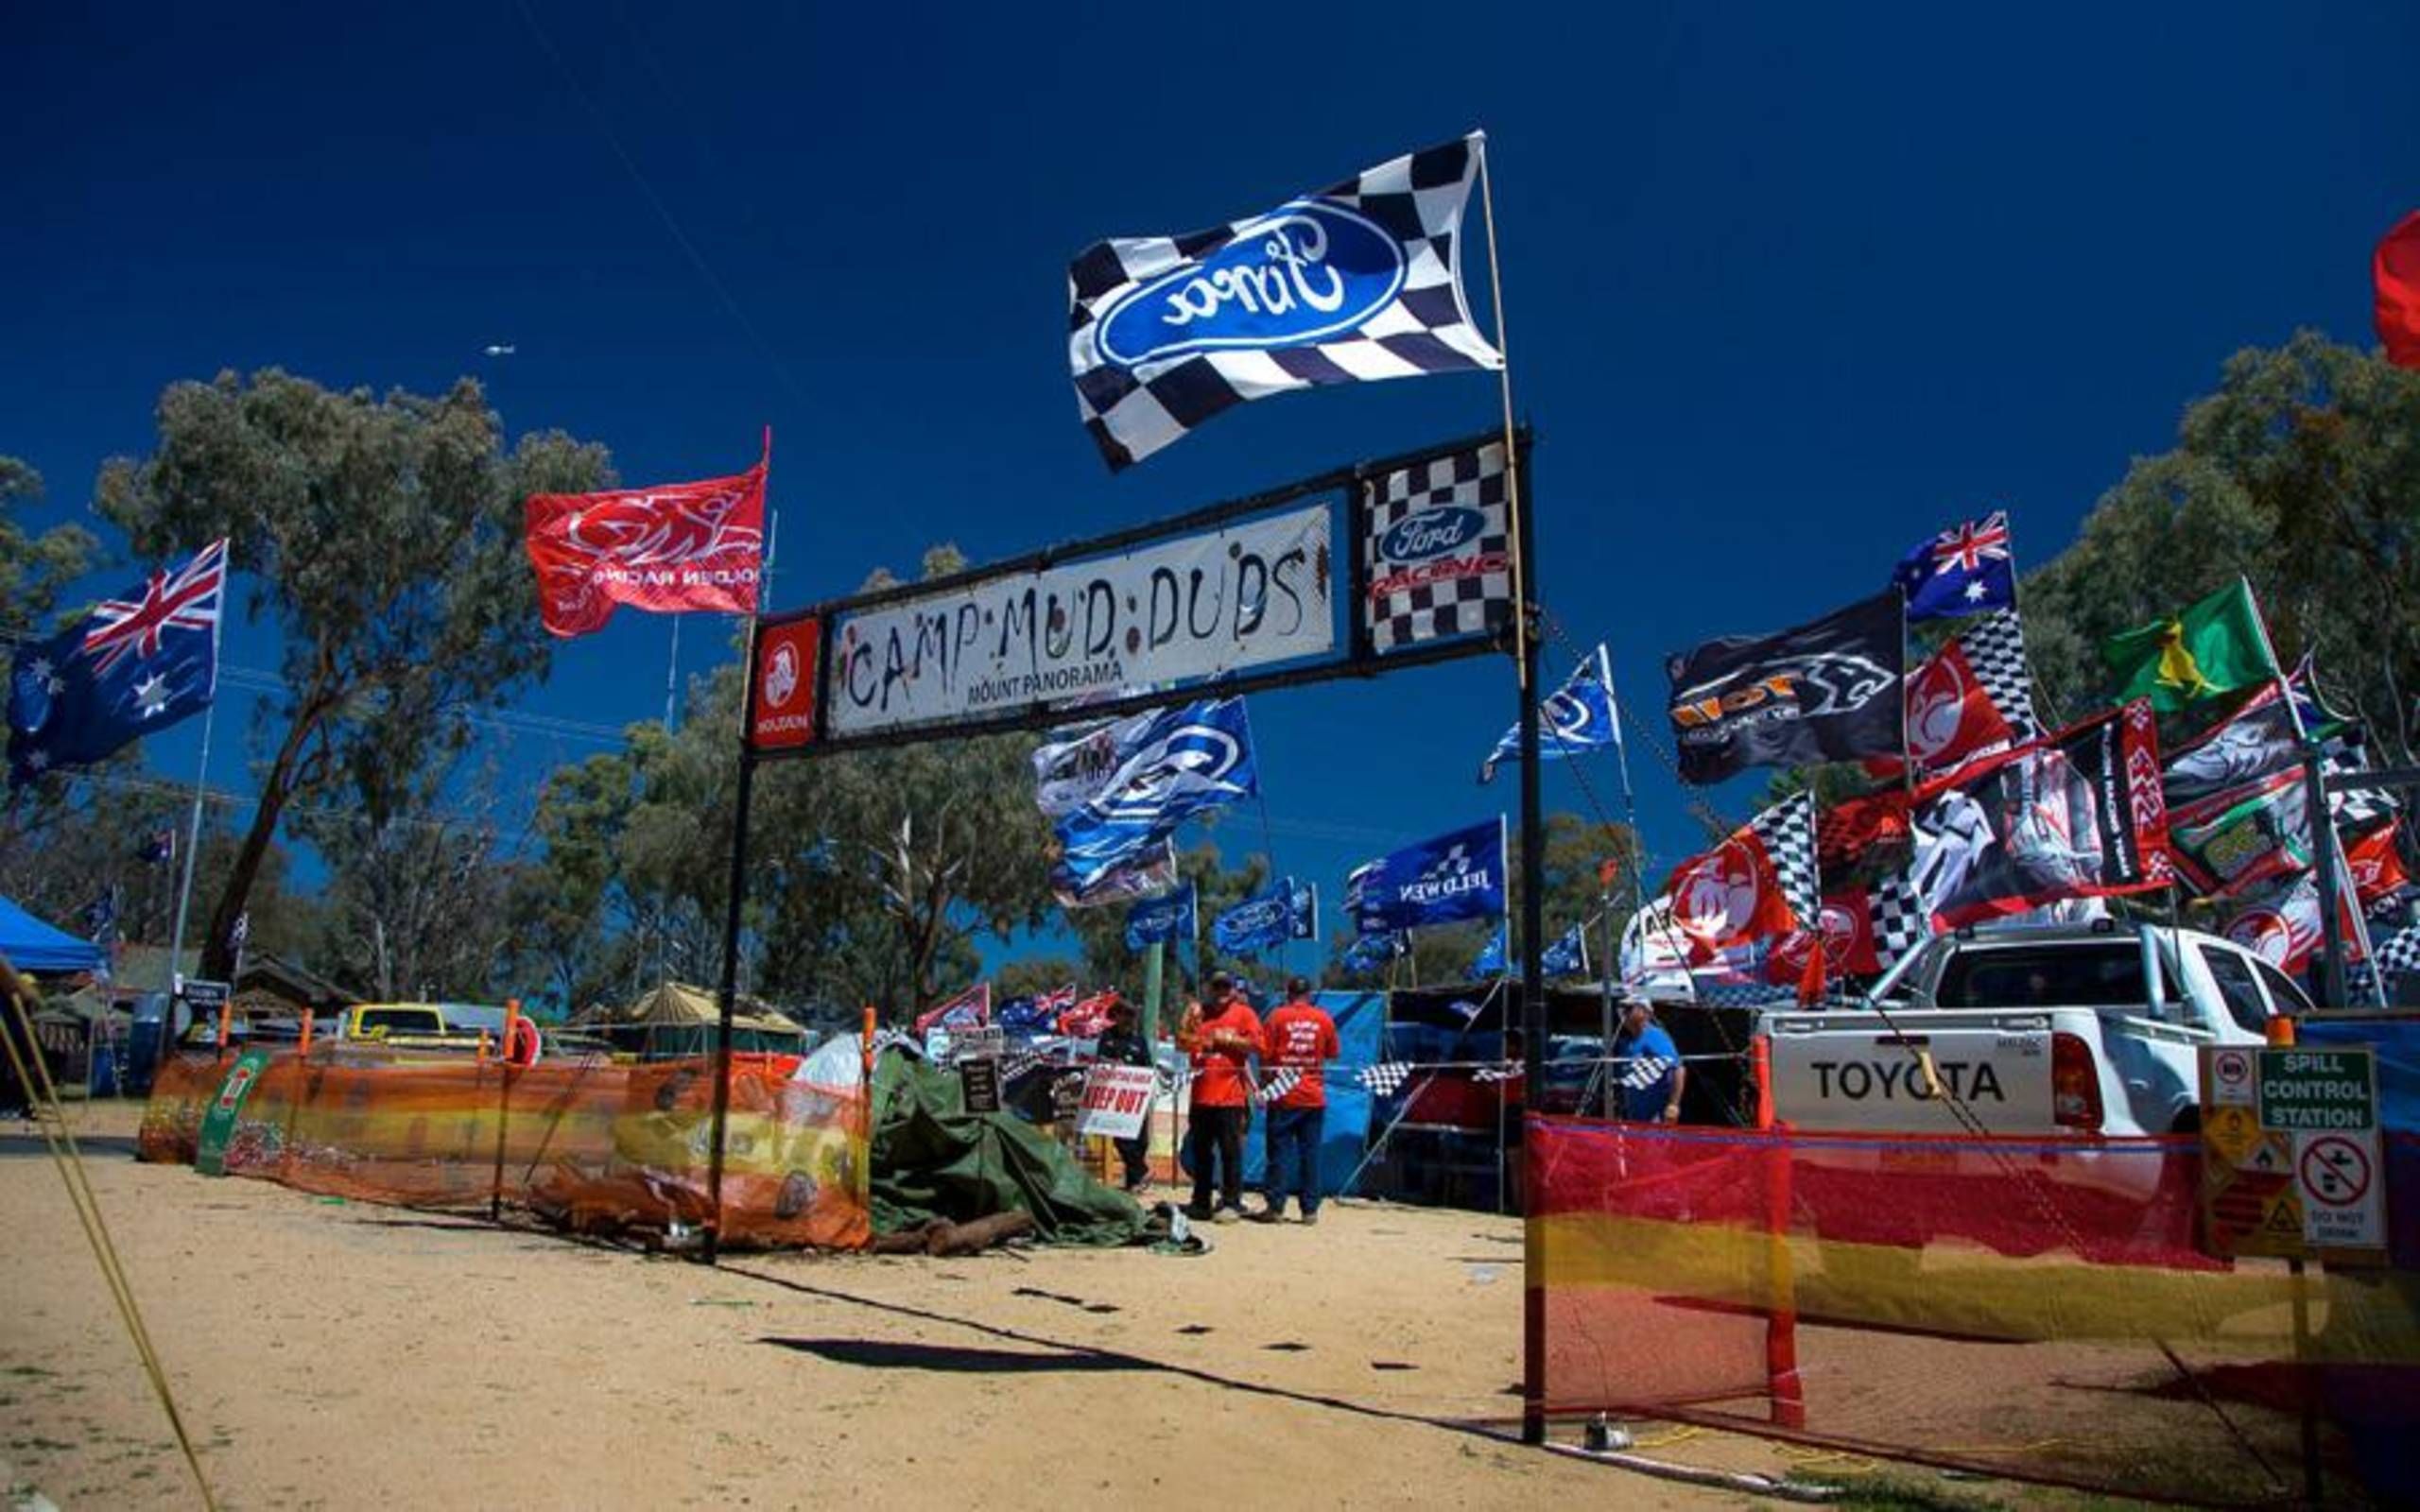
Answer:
[{"left": 1067, "top": 133, "right": 1503, "bottom": 472}]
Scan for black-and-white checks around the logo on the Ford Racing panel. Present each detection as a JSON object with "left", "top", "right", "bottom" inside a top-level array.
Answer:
[{"left": 1362, "top": 440, "right": 1512, "bottom": 653}]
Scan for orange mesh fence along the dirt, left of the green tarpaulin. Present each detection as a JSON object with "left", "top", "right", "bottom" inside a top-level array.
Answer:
[{"left": 140, "top": 1045, "right": 872, "bottom": 1248}]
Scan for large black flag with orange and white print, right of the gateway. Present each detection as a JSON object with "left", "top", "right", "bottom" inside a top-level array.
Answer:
[{"left": 1665, "top": 588, "right": 1907, "bottom": 783}]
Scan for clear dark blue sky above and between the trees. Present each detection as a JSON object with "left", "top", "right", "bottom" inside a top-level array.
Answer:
[{"left": 0, "top": 0, "right": 2420, "bottom": 943}]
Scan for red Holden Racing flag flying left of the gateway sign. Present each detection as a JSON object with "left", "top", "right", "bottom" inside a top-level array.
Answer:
[{"left": 526, "top": 428, "right": 772, "bottom": 636}]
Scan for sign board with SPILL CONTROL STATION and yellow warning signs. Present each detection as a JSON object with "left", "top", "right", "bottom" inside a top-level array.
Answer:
[{"left": 2203, "top": 1045, "right": 2386, "bottom": 1265}]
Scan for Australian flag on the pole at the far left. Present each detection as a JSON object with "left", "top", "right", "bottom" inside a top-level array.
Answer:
[{"left": 8, "top": 540, "right": 228, "bottom": 786}]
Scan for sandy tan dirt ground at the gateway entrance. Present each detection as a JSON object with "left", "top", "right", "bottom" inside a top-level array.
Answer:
[{"left": 0, "top": 1108, "right": 2081, "bottom": 1507}]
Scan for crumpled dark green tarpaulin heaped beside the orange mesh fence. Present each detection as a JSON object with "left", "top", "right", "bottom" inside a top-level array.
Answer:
[{"left": 873, "top": 1050, "right": 1162, "bottom": 1246}]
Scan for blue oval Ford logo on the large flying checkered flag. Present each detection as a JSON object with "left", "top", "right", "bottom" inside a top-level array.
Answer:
[{"left": 1094, "top": 200, "right": 1404, "bottom": 368}]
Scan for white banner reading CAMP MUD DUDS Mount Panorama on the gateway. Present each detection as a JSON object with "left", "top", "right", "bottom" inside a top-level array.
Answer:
[{"left": 825, "top": 501, "right": 1336, "bottom": 735}]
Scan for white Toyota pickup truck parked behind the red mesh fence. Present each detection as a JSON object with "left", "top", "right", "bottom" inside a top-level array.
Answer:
[{"left": 1759, "top": 924, "right": 2311, "bottom": 1137}]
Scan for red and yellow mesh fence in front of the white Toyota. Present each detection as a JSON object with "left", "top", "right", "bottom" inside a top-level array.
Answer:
[{"left": 1527, "top": 1118, "right": 2420, "bottom": 1503}]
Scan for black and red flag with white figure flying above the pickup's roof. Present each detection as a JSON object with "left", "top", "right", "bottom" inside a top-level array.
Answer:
[{"left": 1910, "top": 699, "right": 2175, "bottom": 929}]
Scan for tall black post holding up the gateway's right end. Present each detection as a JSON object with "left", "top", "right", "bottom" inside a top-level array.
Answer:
[{"left": 1512, "top": 438, "right": 1547, "bottom": 1444}]
